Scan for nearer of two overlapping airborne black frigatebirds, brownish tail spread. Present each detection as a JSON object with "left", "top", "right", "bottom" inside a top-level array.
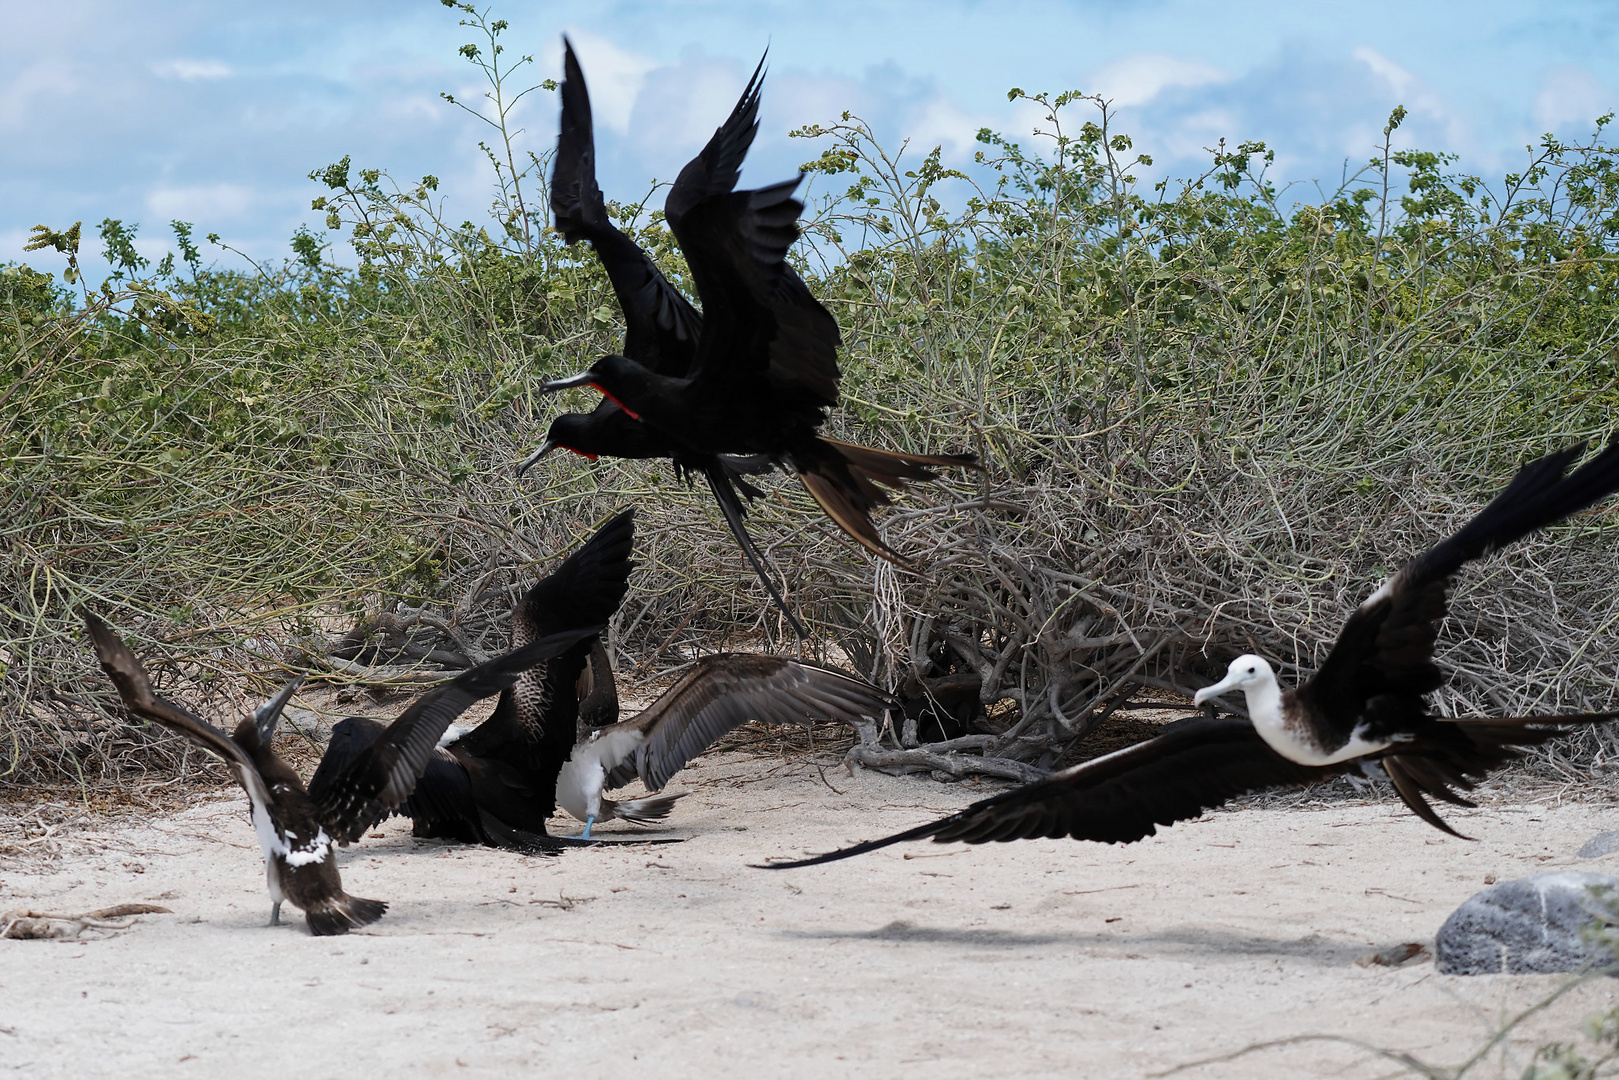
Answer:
[{"left": 542, "top": 42, "right": 976, "bottom": 612}]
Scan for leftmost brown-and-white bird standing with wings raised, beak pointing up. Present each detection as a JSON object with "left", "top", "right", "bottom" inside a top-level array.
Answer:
[{"left": 84, "top": 612, "right": 599, "bottom": 936}]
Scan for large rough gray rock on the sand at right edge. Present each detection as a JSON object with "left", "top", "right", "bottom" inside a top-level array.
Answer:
[{"left": 1434, "top": 871, "right": 1619, "bottom": 975}]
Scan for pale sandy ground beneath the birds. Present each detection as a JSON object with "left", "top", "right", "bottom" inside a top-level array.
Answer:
[{"left": 0, "top": 753, "right": 1619, "bottom": 1078}]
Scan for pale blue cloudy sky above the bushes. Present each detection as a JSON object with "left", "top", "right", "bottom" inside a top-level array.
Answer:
[{"left": 0, "top": 0, "right": 1619, "bottom": 283}]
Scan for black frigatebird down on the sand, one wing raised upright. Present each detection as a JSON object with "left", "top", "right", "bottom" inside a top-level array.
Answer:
[{"left": 312, "top": 510, "right": 635, "bottom": 852}]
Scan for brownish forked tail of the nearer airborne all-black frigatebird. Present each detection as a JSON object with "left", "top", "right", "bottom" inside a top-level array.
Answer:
[{"left": 792, "top": 437, "right": 983, "bottom": 568}]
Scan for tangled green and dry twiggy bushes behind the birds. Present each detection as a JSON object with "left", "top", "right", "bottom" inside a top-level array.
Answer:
[{"left": 0, "top": 8, "right": 1619, "bottom": 790}]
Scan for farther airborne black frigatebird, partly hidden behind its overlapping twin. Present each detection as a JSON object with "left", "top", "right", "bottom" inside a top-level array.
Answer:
[{"left": 516, "top": 37, "right": 810, "bottom": 638}]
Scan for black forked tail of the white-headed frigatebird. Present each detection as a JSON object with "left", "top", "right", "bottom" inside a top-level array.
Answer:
[{"left": 1383, "top": 709, "right": 1619, "bottom": 840}]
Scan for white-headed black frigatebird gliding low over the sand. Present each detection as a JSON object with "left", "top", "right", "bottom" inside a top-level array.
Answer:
[{"left": 769, "top": 439, "right": 1619, "bottom": 870}]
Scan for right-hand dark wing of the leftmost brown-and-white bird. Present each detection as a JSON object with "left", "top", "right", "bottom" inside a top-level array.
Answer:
[{"left": 309, "top": 625, "right": 601, "bottom": 844}]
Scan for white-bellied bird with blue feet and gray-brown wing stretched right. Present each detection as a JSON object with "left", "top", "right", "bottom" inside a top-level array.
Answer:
[{"left": 557, "top": 653, "right": 899, "bottom": 837}]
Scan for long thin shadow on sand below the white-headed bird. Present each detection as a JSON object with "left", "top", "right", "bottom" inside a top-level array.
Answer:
[{"left": 782, "top": 920, "right": 1366, "bottom": 967}]
